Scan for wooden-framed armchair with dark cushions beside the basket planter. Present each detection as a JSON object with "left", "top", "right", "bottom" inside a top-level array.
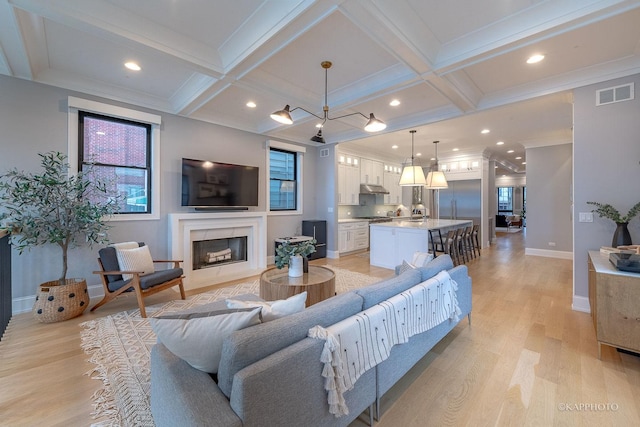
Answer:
[{"left": 91, "top": 243, "right": 186, "bottom": 317}]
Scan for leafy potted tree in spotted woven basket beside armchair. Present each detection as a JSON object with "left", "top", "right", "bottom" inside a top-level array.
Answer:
[{"left": 0, "top": 152, "right": 118, "bottom": 323}]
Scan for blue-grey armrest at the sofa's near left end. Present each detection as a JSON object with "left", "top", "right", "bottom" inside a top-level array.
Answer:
[{"left": 151, "top": 343, "right": 242, "bottom": 427}]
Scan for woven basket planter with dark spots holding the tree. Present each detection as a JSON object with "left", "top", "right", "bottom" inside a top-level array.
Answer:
[{"left": 33, "top": 279, "right": 89, "bottom": 323}]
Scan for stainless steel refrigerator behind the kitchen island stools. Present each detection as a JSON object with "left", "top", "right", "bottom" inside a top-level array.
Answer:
[{"left": 438, "top": 179, "right": 482, "bottom": 224}]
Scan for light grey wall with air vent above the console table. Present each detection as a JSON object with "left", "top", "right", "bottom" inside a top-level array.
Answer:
[{"left": 572, "top": 74, "right": 640, "bottom": 310}]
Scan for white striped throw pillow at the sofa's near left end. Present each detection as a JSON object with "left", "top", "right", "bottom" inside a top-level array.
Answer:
[{"left": 149, "top": 308, "right": 260, "bottom": 374}]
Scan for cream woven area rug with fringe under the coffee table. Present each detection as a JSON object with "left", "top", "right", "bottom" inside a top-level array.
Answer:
[{"left": 80, "top": 266, "right": 380, "bottom": 427}]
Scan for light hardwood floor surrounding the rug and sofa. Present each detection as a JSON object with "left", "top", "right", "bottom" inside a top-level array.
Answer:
[{"left": 0, "top": 233, "right": 640, "bottom": 427}]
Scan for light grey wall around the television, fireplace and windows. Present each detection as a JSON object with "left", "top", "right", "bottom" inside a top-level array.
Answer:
[{"left": 0, "top": 75, "right": 318, "bottom": 308}]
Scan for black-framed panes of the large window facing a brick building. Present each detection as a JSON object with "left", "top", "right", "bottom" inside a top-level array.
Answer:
[{"left": 78, "top": 111, "right": 152, "bottom": 214}]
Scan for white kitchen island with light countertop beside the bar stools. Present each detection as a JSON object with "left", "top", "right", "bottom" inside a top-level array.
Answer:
[{"left": 369, "top": 219, "right": 473, "bottom": 268}]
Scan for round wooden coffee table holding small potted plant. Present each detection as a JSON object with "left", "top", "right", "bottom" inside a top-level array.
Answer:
[{"left": 260, "top": 265, "right": 336, "bottom": 307}]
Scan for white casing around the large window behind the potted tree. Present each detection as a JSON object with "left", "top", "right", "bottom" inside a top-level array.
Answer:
[{"left": 67, "top": 96, "right": 162, "bottom": 221}]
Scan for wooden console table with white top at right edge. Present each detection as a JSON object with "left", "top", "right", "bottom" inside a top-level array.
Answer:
[{"left": 588, "top": 251, "right": 640, "bottom": 358}]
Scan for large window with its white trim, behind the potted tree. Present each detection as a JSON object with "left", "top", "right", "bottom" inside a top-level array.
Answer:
[{"left": 68, "top": 97, "right": 161, "bottom": 221}]
